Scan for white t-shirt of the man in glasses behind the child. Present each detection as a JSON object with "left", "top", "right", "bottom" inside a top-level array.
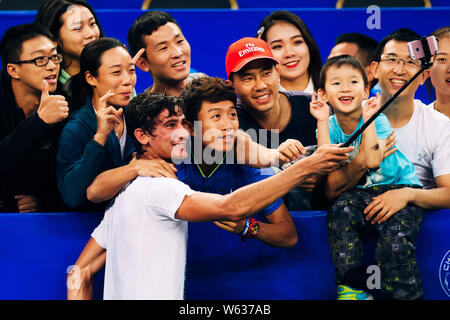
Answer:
[{"left": 395, "top": 100, "right": 450, "bottom": 189}]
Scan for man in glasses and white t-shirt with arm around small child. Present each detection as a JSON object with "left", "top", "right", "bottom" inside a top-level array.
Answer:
[{"left": 326, "top": 29, "right": 450, "bottom": 244}]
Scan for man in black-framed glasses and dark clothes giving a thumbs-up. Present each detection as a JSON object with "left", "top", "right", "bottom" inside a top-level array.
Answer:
[{"left": 0, "top": 24, "right": 69, "bottom": 212}]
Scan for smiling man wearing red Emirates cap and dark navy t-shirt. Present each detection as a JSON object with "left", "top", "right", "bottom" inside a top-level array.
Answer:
[{"left": 229, "top": 38, "right": 323, "bottom": 210}]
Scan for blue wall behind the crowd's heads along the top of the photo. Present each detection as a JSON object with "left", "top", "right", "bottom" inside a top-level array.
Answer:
[{"left": 0, "top": 7, "right": 450, "bottom": 103}]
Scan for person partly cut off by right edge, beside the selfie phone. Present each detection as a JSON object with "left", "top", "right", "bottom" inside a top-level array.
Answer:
[{"left": 430, "top": 26, "right": 450, "bottom": 117}]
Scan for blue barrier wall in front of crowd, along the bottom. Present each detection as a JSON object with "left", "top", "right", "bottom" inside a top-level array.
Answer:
[{"left": 0, "top": 210, "right": 450, "bottom": 300}]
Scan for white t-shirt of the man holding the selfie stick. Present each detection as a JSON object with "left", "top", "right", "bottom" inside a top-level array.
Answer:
[{"left": 92, "top": 177, "right": 194, "bottom": 300}]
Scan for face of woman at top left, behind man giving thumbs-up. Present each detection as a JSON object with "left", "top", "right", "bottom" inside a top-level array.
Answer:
[{"left": 58, "top": 5, "right": 100, "bottom": 59}]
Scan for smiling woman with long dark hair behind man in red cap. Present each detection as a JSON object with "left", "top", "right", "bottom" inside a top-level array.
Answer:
[{"left": 257, "top": 10, "right": 322, "bottom": 93}]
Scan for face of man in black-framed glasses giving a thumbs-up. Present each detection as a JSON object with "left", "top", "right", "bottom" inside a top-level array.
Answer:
[{"left": 8, "top": 36, "right": 60, "bottom": 94}]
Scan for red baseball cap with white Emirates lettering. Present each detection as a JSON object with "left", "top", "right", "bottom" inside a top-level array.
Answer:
[{"left": 225, "top": 38, "right": 278, "bottom": 78}]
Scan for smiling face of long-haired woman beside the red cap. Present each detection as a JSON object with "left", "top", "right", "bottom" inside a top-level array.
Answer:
[{"left": 266, "top": 21, "right": 310, "bottom": 86}]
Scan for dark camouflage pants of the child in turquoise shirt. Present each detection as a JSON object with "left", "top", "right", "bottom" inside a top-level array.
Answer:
[{"left": 327, "top": 185, "right": 423, "bottom": 299}]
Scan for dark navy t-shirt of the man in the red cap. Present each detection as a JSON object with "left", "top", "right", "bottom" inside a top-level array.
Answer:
[{"left": 236, "top": 91, "right": 317, "bottom": 149}]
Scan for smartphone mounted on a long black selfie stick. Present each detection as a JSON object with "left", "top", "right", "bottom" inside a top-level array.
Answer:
[{"left": 342, "top": 36, "right": 438, "bottom": 147}]
